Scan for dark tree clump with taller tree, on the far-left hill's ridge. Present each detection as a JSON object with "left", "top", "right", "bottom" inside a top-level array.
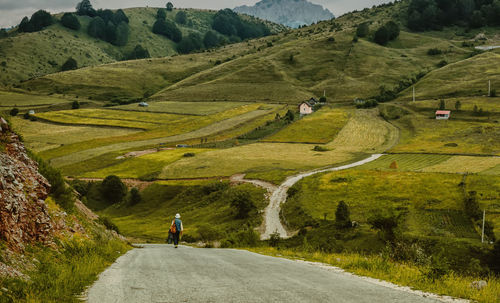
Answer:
[{"left": 76, "top": 0, "right": 130, "bottom": 46}]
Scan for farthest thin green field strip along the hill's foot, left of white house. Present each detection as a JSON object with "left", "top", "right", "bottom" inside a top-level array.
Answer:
[{"left": 112, "top": 101, "right": 250, "bottom": 116}]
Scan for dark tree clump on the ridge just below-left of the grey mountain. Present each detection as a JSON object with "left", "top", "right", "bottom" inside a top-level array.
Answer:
[{"left": 212, "top": 9, "right": 270, "bottom": 40}]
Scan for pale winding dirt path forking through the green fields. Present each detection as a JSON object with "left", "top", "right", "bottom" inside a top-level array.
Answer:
[{"left": 231, "top": 154, "right": 383, "bottom": 240}]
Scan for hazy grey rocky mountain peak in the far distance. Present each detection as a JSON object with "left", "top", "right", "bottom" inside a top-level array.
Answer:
[{"left": 234, "top": 0, "right": 335, "bottom": 28}]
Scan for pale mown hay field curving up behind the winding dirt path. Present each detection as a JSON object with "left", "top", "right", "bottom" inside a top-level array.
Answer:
[{"left": 160, "top": 110, "right": 397, "bottom": 179}]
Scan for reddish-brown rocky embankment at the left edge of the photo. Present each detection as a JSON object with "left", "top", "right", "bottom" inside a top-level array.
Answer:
[{"left": 0, "top": 118, "right": 53, "bottom": 251}]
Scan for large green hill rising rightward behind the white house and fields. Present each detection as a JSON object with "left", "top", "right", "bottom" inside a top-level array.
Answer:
[{"left": 12, "top": 2, "right": 500, "bottom": 104}]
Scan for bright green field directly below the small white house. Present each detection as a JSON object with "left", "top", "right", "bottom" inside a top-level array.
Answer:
[{"left": 262, "top": 108, "right": 349, "bottom": 144}]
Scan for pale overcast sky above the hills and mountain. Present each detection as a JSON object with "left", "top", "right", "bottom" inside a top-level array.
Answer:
[{"left": 0, "top": 0, "right": 389, "bottom": 27}]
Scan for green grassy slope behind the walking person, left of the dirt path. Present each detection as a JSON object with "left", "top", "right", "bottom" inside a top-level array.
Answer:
[{"left": 100, "top": 181, "right": 266, "bottom": 243}]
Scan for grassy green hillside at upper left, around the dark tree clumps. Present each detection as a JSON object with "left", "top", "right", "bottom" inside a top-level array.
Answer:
[{"left": 0, "top": 7, "right": 284, "bottom": 86}]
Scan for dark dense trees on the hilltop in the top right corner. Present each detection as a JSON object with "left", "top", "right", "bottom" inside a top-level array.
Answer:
[{"left": 408, "top": 0, "right": 500, "bottom": 31}]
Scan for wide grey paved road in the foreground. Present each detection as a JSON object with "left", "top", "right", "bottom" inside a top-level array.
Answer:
[{"left": 88, "top": 244, "right": 446, "bottom": 303}]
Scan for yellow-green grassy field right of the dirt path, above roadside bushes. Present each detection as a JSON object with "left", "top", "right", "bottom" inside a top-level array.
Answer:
[{"left": 284, "top": 170, "right": 500, "bottom": 241}]
